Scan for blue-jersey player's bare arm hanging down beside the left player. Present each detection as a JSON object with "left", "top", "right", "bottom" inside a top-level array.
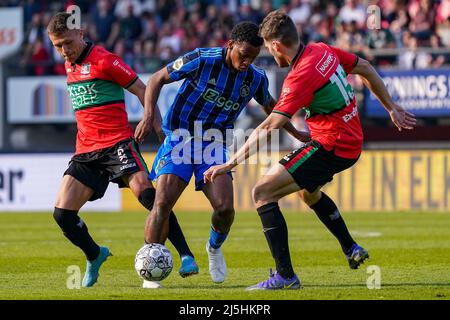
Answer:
[{"left": 134, "top": 68, "right": 170, "bottom": 143}]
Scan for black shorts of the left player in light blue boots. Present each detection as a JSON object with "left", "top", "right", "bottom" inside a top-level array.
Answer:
[{"left": 64, "top": 139, "right": 148, "bottom": 201}]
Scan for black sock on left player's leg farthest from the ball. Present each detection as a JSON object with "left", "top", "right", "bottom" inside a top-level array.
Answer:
[{"left": 53, "top": 208, "right": 100, "bottom": 261}]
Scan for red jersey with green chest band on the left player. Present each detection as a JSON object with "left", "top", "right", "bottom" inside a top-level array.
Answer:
[{"left": 65, "top": 43, "right": 138, "bottom": 154}]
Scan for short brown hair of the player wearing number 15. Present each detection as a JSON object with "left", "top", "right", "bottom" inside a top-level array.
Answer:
[{"left": 259, "top": 10, "right": 299, "bottom": 46}]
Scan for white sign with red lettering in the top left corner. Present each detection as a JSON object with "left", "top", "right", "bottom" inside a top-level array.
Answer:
[{"left": 0, "top": 7, "right": 23, "bottom": 61}]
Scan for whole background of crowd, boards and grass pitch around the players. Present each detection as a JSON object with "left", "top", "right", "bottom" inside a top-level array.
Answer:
[{"left": 0, "top": 0, "right": 450, "bottom": 299}]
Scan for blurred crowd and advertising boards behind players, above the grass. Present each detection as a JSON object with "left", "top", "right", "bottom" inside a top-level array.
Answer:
[{"left": 0, "top": 0, "right": 450, "bottom": 212}]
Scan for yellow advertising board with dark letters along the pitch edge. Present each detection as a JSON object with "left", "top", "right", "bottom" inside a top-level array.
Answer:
[{"left": 122, "top": 150, "right": 450, "bottom": 211}]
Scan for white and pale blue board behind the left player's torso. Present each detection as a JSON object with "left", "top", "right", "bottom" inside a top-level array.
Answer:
[{"left": 7, "top": 71, "right": 276, "bottom": 123}]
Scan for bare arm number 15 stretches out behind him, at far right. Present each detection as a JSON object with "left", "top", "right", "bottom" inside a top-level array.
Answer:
[{"left": 351, "top": 58, "right": 416, "bottom": 131}]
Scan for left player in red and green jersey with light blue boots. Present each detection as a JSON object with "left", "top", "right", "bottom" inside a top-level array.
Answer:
[{"left": 47, "top": 12, "right": 198, "bottom": 287}]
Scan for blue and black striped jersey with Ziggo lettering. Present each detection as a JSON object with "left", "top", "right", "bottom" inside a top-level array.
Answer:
[{"left": 163, "top": 48, "right": 270, "bottom": 135}]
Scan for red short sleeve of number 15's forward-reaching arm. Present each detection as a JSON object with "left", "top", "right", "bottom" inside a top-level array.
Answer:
[{"left": 272, "top": 72, "right": 314, "bottom": 118}]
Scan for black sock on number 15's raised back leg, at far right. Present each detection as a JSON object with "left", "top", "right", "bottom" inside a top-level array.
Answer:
[{"left": 311, "top": 192, "right": 355, "bottom": 254}]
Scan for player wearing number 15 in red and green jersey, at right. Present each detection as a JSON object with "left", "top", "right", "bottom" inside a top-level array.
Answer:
[{"left": 205, "top": 11, "right": 416, "bottom": 290}]
